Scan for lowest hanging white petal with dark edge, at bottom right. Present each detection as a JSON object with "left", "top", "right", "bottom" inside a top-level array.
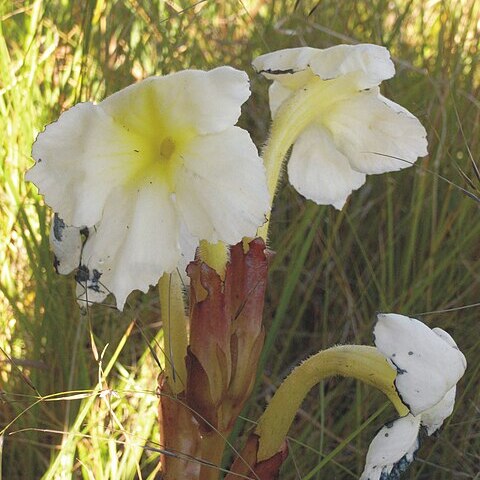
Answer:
[{"left": 360, "top": 415, "right": 420, "bottom": 480}]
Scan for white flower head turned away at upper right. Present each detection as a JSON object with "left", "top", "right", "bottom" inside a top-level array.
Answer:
[{"left": 253, "top": 44, "right": 427, "bottom": 209}]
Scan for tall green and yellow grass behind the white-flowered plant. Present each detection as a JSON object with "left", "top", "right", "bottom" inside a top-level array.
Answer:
[{"left": 0, "top": 0, "right": 480, "bottom": 480}]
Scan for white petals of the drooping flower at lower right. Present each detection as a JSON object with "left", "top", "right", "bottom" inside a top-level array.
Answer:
[{"left": 360, "top": 313, "right": 467, "bottom": 480}]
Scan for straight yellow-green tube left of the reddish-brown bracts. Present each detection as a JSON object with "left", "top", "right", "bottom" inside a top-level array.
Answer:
[{"left": 158, "top": 272, "right": 188, "bottom": 394}]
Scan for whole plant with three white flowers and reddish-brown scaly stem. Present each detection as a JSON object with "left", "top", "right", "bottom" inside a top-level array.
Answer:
[{"left": 26, "top": 45, "right": 466, "bottom": 480}]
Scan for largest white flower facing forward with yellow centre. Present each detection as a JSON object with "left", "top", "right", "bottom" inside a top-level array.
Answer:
[{"left": 26, "top": 67, "right": 268, "bottom": 308}]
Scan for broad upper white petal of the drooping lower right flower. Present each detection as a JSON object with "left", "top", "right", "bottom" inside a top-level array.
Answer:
[{"left": 374, "top": 313, "right": 466, "bottom": 415}]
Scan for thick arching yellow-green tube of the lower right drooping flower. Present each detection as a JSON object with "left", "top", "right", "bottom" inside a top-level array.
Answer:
[{"left": 255, "top": 345, "right": 408, "bottom": 462}]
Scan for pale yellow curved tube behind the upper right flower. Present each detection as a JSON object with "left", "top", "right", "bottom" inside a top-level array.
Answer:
[{"left": 257, "top": 74, "right": 358, "bottom": 240}]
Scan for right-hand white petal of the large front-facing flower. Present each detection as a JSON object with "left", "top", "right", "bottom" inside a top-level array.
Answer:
[{"left": 176, "top": 127, "right": 268, "bottom": 244}]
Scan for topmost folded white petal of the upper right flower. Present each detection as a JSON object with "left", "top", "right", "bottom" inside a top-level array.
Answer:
[{"left": 253, "top": 44, "right": 395, "bottom": 90}]
